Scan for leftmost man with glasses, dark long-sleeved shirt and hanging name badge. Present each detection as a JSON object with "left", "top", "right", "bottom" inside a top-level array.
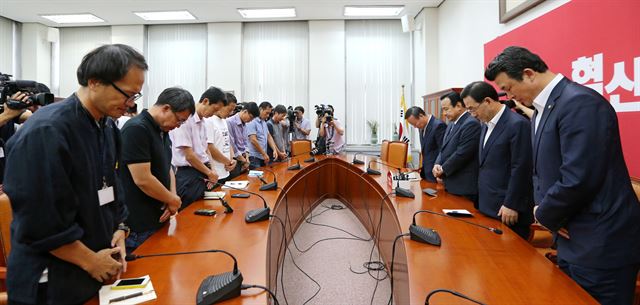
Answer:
[{"left": 4, "top": 44, "right": 147, "bottom": 304}]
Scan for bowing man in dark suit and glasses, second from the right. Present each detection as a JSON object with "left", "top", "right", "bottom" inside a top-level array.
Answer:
[{"left": 460, "top": 82, "right": 533, "bottom": 239}]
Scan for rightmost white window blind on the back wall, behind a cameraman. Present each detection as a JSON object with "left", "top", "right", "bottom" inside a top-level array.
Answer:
[{"left": 345, "top": 20, "right": 411, "bottom": 145}]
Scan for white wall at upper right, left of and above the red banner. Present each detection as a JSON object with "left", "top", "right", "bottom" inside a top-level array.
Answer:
[{"left": 436, "top": 0, "right": 569, "bottom": 92}]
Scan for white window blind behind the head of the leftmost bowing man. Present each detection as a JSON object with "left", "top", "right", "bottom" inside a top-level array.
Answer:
[{"left": 58, "top": 26, "right": 111, "bottom": 97}]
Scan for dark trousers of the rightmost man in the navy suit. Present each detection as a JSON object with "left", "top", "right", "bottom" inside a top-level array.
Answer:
[{"left": 558, "top": 259, "right": 640, "bottom": 305}]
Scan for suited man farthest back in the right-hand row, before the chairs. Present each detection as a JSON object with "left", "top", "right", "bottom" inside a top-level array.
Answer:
[{"left": 404, "top": 106, "right": 447, "bottom": 182}]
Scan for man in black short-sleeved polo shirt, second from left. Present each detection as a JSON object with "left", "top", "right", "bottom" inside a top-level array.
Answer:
[{"left": 120, "top": 87, "right": 195, "bottom": 253}]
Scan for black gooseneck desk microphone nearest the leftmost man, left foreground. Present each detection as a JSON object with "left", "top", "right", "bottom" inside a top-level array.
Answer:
[{"left": 125, "top": 249, "right": 242, "bottom": 305}]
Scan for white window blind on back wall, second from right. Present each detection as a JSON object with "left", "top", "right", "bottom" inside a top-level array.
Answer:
[{"left": 240, "top": 21, "right": 309, "bottom": 107}]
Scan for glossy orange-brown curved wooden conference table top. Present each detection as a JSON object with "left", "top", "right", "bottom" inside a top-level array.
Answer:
[{"left": 89, "top": 155, "right": 597, "bottom": 304}]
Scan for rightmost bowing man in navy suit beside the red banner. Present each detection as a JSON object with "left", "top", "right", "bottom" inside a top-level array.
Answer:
[{"left": 485, "top": 47, "right": 640, "bottom": 304}]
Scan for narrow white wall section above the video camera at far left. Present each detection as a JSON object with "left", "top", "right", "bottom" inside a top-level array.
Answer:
[{"left": 20, "top": 23, "right": 52, "bottom": 88}]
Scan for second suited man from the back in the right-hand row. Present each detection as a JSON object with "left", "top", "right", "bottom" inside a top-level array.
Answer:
[{"left": 433, "top": 92, "right": 480, "bottom": 206}]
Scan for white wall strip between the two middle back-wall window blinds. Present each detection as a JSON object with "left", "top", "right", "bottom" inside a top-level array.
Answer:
[{"left": 207, "top": 22, "right": 243, "bottom": 101}]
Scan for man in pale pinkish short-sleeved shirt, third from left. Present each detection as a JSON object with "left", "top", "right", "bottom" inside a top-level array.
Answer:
[{"left": 169, "top": 87, "right": 227, "bottom": 208}]
